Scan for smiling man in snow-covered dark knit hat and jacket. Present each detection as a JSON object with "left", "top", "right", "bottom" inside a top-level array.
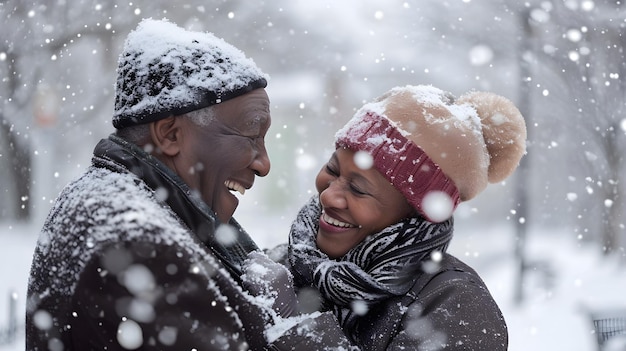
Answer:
[{"left": 26, "top": 20, "right": 352, "bottom": 351}]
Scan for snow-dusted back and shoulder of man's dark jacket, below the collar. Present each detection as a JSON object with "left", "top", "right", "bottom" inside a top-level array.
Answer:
[{"left": 26, "top": 164, "right": 264, "bottom": 350}]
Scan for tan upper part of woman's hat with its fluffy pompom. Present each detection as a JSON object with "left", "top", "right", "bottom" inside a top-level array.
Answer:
[{"left": 372, "top": 85, "right": 526, "bottom": 201}]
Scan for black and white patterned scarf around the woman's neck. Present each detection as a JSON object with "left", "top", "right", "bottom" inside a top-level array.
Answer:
[{"left": 288, "top": 195, "right": 453, "bottom": 331}]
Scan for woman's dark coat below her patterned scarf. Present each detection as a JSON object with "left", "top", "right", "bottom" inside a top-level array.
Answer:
[{"left": 356, "top": 254, "right": 508, "bottom": 351}]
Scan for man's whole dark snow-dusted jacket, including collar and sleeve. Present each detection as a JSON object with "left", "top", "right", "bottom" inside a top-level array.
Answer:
[{"left": 26, "top": 135, "right": 352, "bottom": 351}]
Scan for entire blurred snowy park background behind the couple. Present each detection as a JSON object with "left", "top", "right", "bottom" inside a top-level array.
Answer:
[{"left": 0, "top": 0, "right": 626, "bottom": 351}]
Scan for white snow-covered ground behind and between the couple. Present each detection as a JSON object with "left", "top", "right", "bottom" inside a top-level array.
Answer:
[{"left": 0, "top": 216, "right": 626, "bottom": 351}]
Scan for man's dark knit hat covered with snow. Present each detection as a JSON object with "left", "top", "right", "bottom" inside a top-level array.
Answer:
[{"left": 113, "top": 19, "right": 267, "bottom": 129}]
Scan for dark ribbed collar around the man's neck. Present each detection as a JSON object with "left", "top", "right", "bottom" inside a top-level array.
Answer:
[{"left": 92, "top": 134, "right": 258, "bottom": 281}]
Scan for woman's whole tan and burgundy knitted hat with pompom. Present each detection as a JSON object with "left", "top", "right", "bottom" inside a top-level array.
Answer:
[{"left": 335, "top": 85, "right": 526, "bottom": 222}]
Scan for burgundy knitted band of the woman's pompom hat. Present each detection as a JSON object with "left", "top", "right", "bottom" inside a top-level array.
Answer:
[{"left": 335, "top": 111, "right": 460, "bottom": 220}]
